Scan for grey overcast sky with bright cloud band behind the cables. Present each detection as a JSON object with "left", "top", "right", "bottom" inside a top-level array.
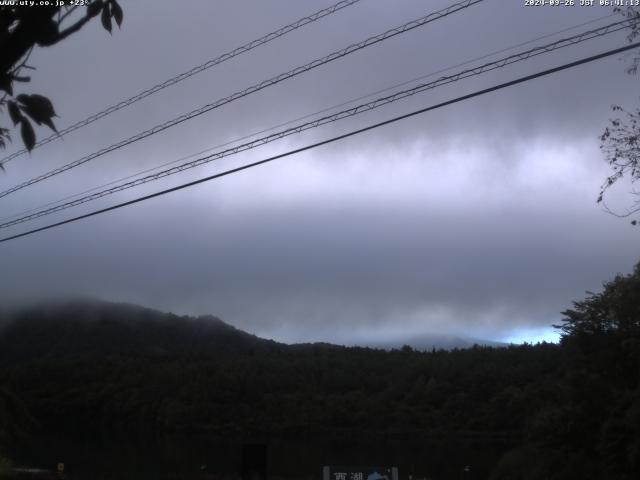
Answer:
[{"left": 0, "top": 0, "right": 640, "bottom": 344}]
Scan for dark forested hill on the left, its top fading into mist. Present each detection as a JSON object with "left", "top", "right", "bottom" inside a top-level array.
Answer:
[{"left": 0, "top": 300, "right": 284, "bottom": 363}]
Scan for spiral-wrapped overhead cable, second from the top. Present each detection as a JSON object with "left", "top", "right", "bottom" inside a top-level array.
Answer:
[{"left": 0, "top": 0, "right": 484, "bottom": 198}]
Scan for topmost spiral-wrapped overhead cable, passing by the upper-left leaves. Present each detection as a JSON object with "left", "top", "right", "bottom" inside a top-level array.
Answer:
[{"left": 0, "top": 0, "right": 360, "bottom": 165}]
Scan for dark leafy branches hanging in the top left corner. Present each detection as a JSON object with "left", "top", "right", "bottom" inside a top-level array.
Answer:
[{"left": 0, "top": 0, "right": 123, "bottom": 158}]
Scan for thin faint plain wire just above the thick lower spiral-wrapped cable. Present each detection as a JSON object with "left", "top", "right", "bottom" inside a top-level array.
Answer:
[{"left": 0, "top": 13, "right": 617, "bottom": 228}]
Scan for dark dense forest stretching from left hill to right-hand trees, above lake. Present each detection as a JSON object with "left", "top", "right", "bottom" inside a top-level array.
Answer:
[{"left": 0, "top": 264, "right": 640, "bottom": 479}]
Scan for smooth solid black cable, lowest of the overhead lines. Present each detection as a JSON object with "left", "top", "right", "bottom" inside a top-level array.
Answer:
[{"left": 0, "top": 42, "right": 640, "bottom": 243}]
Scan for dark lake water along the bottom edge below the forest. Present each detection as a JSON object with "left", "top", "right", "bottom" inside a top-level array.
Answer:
[{"left": 3, "top": 435, "right": 510, "bottom": 480}]
